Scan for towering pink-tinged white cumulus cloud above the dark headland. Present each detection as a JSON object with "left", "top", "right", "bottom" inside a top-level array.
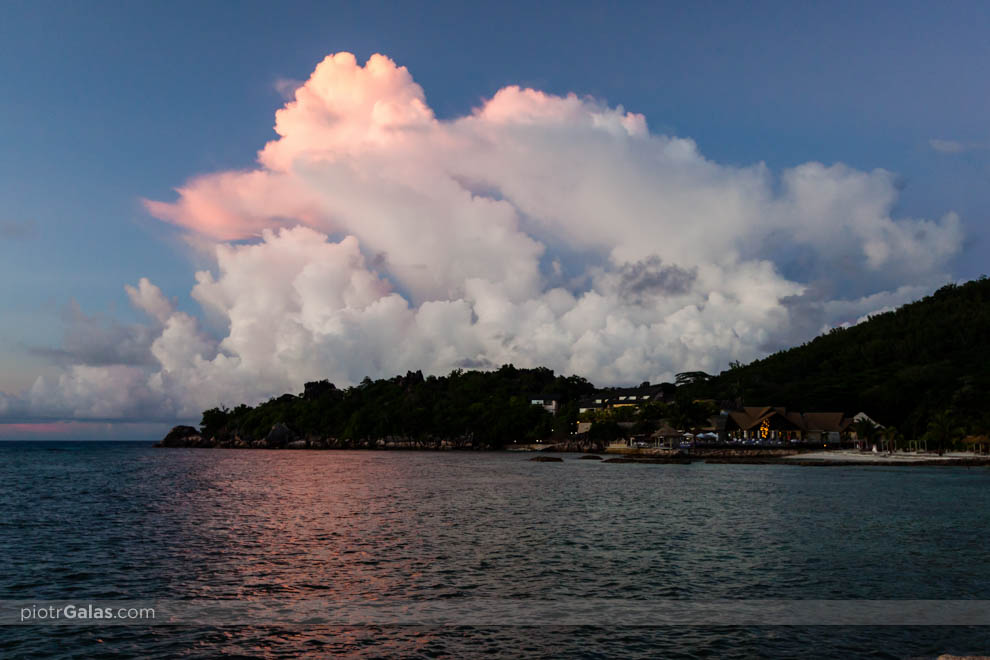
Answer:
[{"left": 15, "top": 53, "right": 962, "bottom": 417}]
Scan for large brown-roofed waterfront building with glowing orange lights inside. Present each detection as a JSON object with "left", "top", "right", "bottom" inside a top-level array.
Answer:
[{"left": 724, "top": 406, "right": 852, "bottom": 443}]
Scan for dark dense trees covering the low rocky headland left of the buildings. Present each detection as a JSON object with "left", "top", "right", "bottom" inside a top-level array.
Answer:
[{"left": 201, "top": 365, "right": 594, "bottom": 447}]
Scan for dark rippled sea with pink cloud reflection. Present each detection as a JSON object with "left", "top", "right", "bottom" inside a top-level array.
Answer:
[{"left": 0, "top": 442, "right": 990, "bottom": 658}]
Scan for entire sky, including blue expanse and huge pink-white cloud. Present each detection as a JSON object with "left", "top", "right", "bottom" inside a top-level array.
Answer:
[{"left": 0, "top": 2, "right": 990, "bottom": 439}]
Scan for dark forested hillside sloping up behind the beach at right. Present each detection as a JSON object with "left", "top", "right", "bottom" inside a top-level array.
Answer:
[{"left": 691, "top": 276, "right": 990, "bottom": 437}]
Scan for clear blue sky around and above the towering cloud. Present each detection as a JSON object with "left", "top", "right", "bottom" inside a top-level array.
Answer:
[{"left": 0, "top": 1, "right": 990, "bottom": 438}]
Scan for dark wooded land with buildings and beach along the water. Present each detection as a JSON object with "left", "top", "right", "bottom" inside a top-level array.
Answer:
[{"left": 158, "top": 277, "right": 990, "bottom": 465}]
